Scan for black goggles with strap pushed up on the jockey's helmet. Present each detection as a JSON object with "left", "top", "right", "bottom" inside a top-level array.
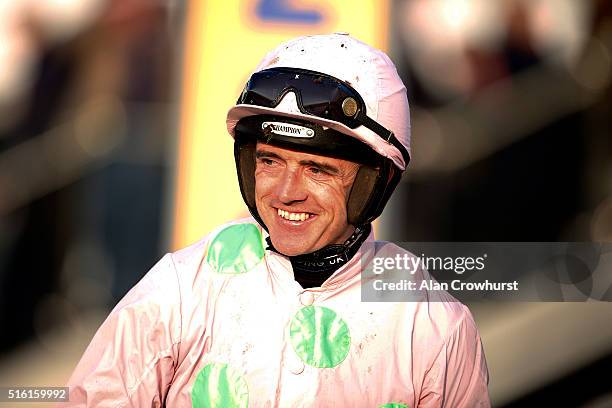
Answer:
[{"left": 237, "top": 68, "right": 410, "bottom": 163}]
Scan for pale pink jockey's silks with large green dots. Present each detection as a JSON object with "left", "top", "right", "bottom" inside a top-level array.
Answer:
[{"left": 64, "top": 219, "right": 490, "bottom": 408}]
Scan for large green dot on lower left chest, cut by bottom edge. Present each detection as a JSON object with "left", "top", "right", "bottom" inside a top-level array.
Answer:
[{"left": 191, "top": 363, "right": 249, "bottom": 408}]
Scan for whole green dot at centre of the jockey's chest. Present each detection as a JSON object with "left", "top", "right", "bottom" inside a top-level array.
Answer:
[{"left": 289, "top": 306, "right": 351, "bottom": 368}]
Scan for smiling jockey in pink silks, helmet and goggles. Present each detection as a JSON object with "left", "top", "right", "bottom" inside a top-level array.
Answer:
[{"left": 64, "top": 34, "right": 489, "bottom": 407}]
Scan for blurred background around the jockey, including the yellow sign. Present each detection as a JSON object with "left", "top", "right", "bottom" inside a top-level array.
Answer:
[{"left": 0, "top": 0, "right": 612, "bottom": 408}]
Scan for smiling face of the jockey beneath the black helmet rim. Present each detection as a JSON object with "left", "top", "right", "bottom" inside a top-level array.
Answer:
[{"left": 255, "top": 143, "right": 359, "bottom": 256}]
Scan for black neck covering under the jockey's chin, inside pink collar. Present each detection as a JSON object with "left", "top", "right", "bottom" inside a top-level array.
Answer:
[{"left": 266, "top": 224, "right": 372, "bottom": 289}]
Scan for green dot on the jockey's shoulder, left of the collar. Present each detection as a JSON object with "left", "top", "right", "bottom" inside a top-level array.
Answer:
[{"left": 206, "top": 224, "right": 264, "bottom": 274}]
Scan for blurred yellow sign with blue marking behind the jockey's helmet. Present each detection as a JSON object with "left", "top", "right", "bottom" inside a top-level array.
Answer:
[{"left": 172, "top": 0, "right": 389, "bottom": 249}]
